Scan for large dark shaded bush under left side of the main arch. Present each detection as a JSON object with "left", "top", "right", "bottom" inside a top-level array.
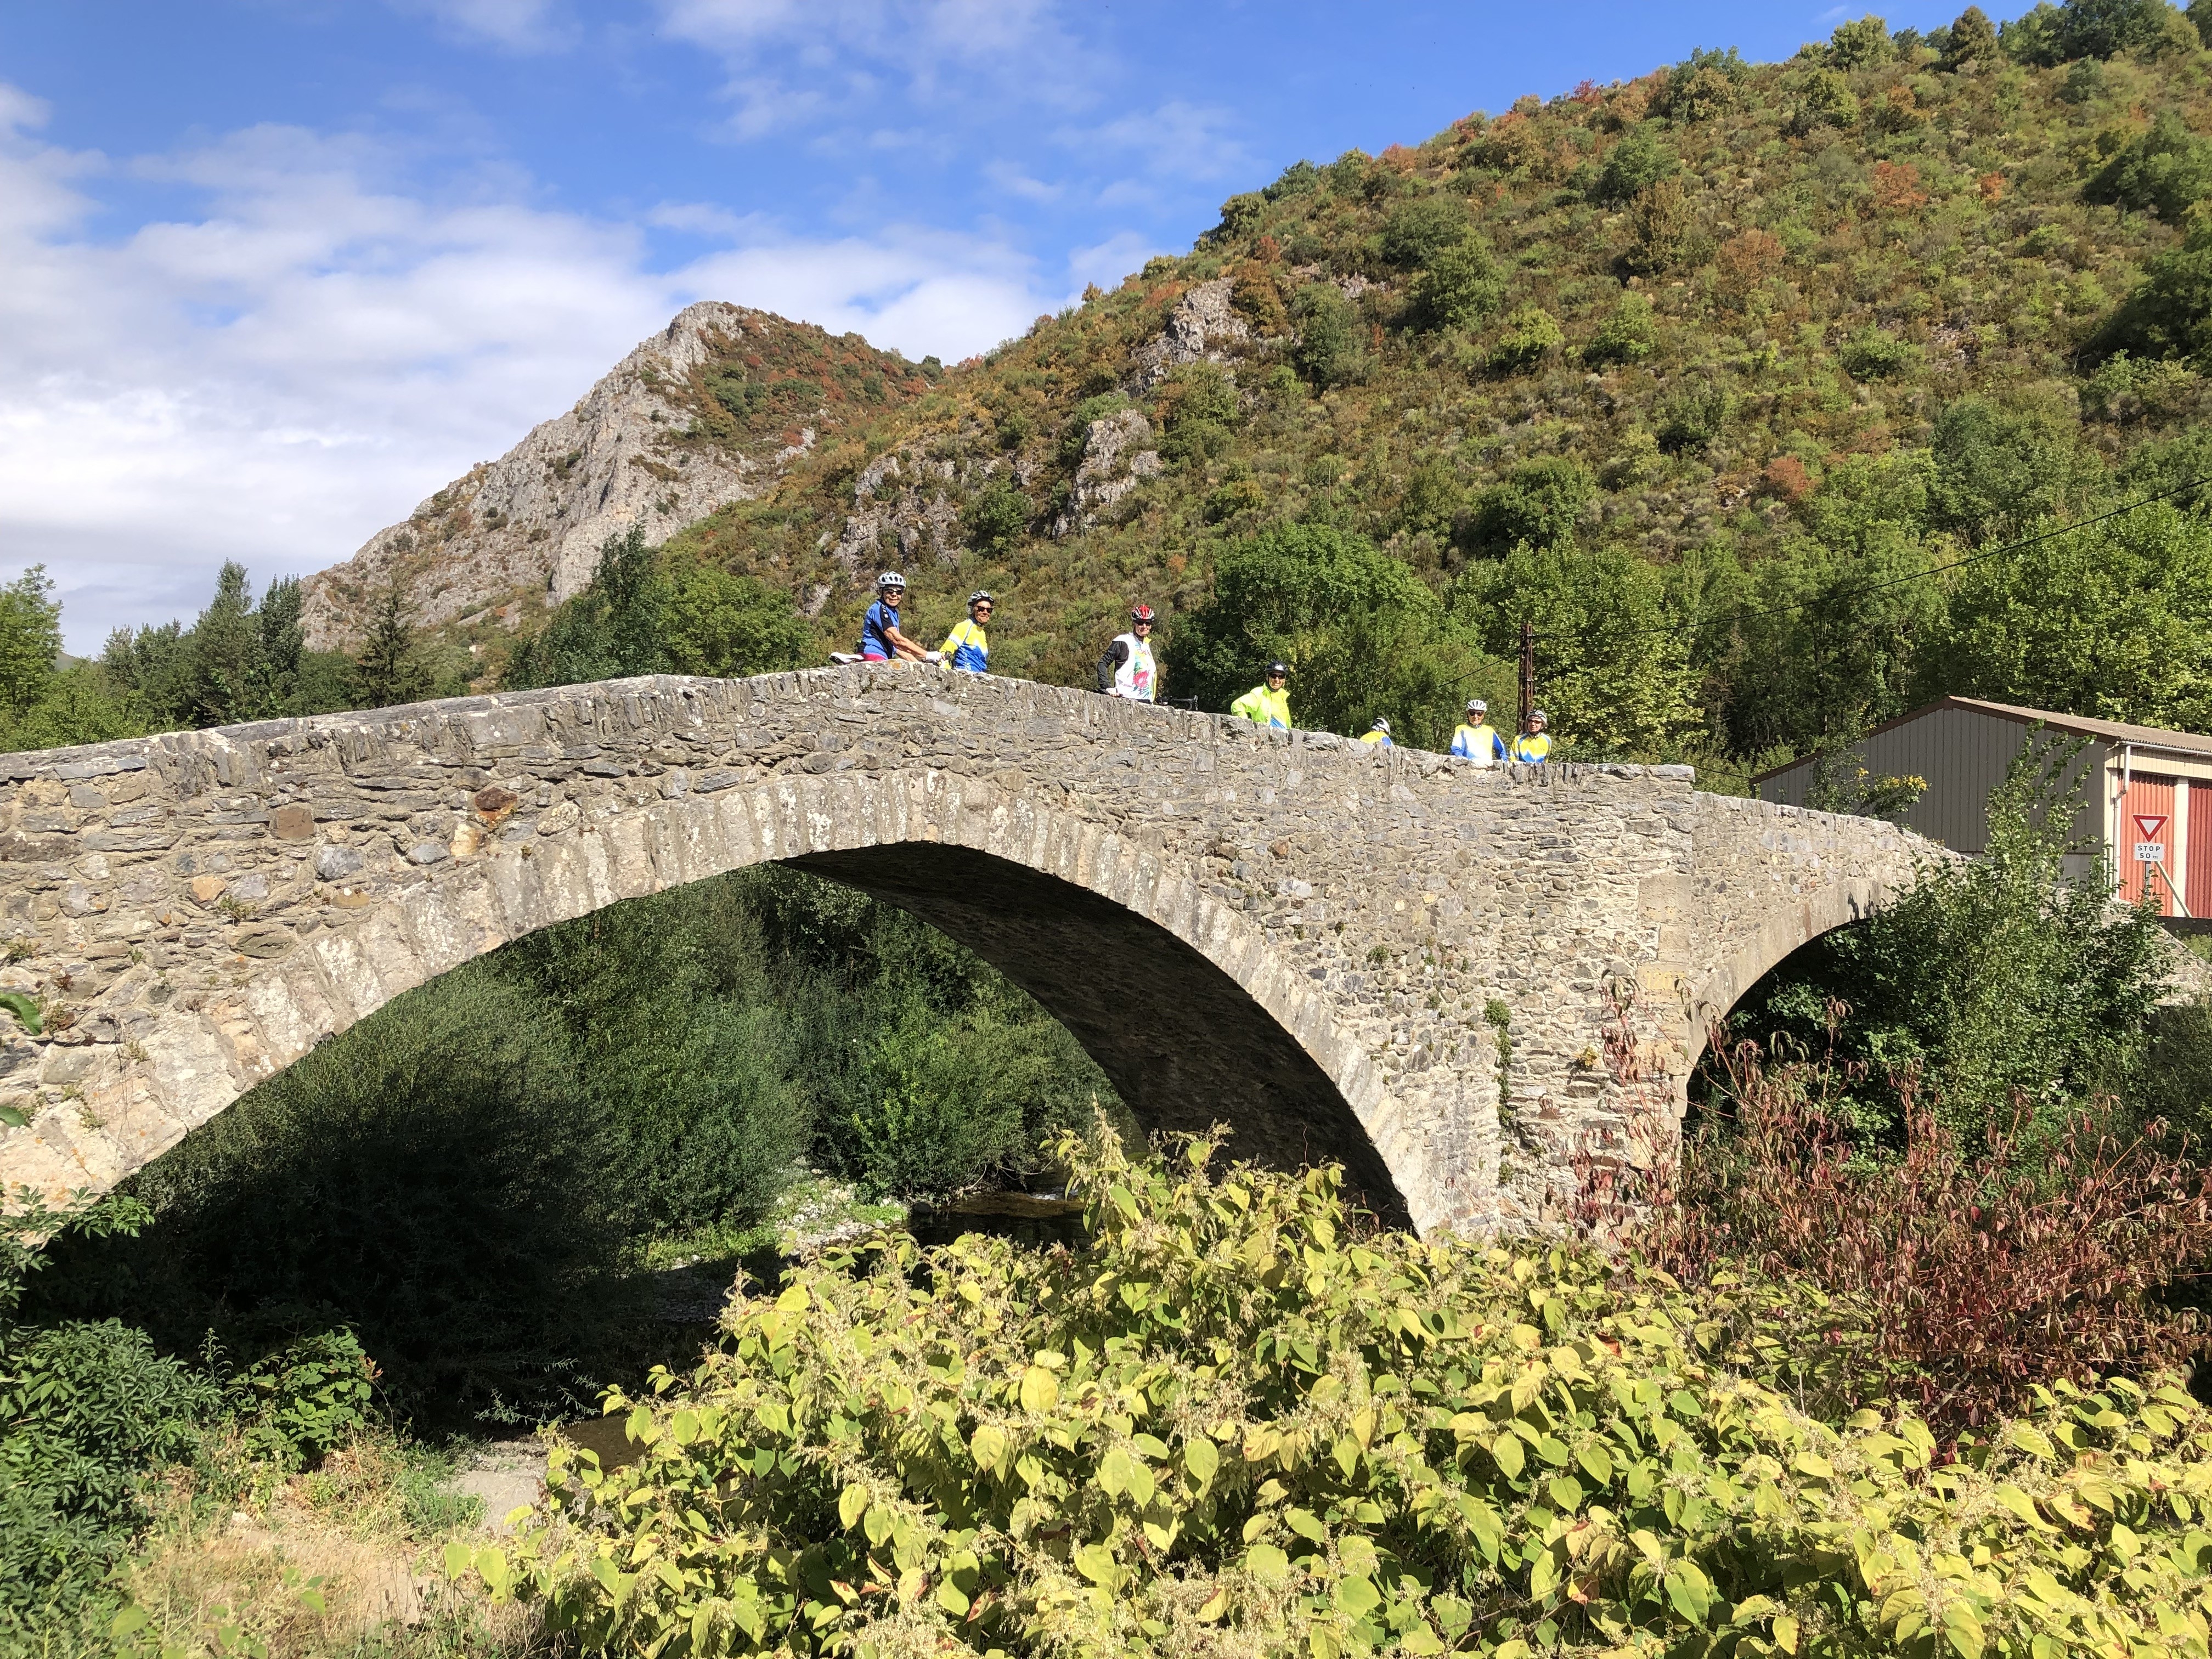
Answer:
[{"left": 38, "top": 962, "right": 630, "bottom": 1413}]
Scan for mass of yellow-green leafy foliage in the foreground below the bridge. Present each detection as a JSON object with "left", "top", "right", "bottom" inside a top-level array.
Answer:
[{"left": 449, "top": 1139, "right": 2212, "bottom": 1659}]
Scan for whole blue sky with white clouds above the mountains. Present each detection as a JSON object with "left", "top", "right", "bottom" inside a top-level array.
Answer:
[{"left": 0, "top": 0, "right": 1990, "bottom": 650}]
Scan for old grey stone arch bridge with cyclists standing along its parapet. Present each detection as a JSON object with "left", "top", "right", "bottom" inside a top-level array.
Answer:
[{"left": 0, "top": 668, "right": 1933, "bottom": 1232}]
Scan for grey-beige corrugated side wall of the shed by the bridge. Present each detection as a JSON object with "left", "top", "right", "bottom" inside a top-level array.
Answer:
[{"left": 1758, "top": 708, "right": 2106, "bottom": 851}]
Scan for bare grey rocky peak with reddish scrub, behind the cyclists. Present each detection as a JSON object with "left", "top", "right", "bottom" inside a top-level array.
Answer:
[{"left": 303, "top": 301, "right": 927, "bottom": 650}]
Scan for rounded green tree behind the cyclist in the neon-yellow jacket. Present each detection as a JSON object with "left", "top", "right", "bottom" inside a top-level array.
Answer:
[{"left": 1166, "top": 524, "right": 1502, "bottom": 748}]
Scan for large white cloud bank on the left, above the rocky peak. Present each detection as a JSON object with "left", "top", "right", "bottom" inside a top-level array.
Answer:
[{"left": 0, "top": 86, "right": 1059, "bottom": 650}]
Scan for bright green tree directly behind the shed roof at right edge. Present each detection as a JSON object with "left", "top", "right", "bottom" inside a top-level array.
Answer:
[{"left": 1920, "top": 502, "right": 2212, "bottom": 732}]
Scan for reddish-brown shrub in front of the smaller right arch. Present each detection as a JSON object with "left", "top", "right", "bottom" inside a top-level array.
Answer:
[{"left": 1639, "top": 1033, "right": 2212, "bottom": 1434}]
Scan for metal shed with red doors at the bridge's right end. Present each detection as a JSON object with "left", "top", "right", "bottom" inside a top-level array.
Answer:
[{"left": 1752, "top": 697, "right": 2212, "bottom": 918}]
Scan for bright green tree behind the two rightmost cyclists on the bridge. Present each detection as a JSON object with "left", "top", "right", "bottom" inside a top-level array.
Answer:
[{"left": 1451, "top": 544, "right": 1699, "bottom": 757}]
